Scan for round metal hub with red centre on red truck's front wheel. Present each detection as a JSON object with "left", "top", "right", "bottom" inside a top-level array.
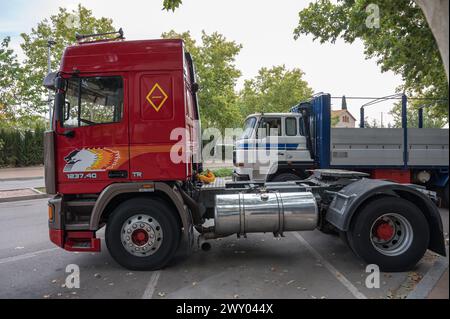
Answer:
[{"left": 121, "top": 214, "right": 163, "bottom": 257}]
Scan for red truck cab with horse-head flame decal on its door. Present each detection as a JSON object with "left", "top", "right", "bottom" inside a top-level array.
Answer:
[{"left": 44, "top": 39, "right": 201, "bottom": 262}]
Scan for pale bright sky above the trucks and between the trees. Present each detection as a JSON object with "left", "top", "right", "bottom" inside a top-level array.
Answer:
[{"left": 0, "top": 0, "right": 402, "bottom": 125}]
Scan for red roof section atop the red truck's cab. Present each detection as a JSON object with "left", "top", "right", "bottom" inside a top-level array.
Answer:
[{"left": 60, "top": 39, "right": 184, "bottom": 73}]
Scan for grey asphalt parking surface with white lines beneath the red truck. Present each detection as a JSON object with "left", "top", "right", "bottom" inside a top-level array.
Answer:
[{"left": 0, "top": 199, "right": 448, "bottom": 299}]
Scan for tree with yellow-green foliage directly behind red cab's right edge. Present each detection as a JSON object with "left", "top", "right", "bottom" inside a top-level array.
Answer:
[{"left": 162, "top": 30, "right": 242, "bottom": 131}]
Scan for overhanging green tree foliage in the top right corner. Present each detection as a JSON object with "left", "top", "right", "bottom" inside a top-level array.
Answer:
[{"left": 294, "top": 0, "right": 448, "bottom": 119}]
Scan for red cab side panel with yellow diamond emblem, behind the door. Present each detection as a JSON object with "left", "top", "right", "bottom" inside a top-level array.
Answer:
[{"left": 130, "top": 71, "right": 187, "bottom": 180}]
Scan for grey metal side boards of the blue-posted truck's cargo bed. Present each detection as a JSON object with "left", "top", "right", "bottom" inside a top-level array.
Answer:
[{"left": 330, "top": 128, "right": 449, "bottom": 166}]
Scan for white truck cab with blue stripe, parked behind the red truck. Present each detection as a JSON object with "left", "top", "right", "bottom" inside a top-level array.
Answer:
[{"left": 233, "top": 113, "right": 313, "bottom": 181}]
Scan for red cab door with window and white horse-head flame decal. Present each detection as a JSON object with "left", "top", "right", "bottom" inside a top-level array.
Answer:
[{"left": 56, "top": 73, "right": 129, "bottom": 194}]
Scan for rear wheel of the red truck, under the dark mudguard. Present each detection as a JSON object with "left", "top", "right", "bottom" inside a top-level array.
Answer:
[{"left": 347, "top": 197, "right": 430, "bottom": 272}]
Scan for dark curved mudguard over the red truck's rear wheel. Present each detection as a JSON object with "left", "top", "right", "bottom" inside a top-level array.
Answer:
[{"left": 325, "top": 178, "right": 446, "bottom": 256}]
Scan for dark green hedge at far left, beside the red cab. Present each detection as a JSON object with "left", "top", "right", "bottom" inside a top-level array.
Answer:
[{"left": 0, "top": 127, "right": 44, "bottom": 167}]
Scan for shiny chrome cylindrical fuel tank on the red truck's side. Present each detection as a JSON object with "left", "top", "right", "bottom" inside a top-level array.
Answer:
[{"left": 214, "top": 192, "right": 319, "bottom": 235}]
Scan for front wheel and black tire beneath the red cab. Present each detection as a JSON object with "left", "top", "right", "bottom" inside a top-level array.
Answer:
[{"left": 105, "top": 198, "right": 181, "bottom": 270}]
